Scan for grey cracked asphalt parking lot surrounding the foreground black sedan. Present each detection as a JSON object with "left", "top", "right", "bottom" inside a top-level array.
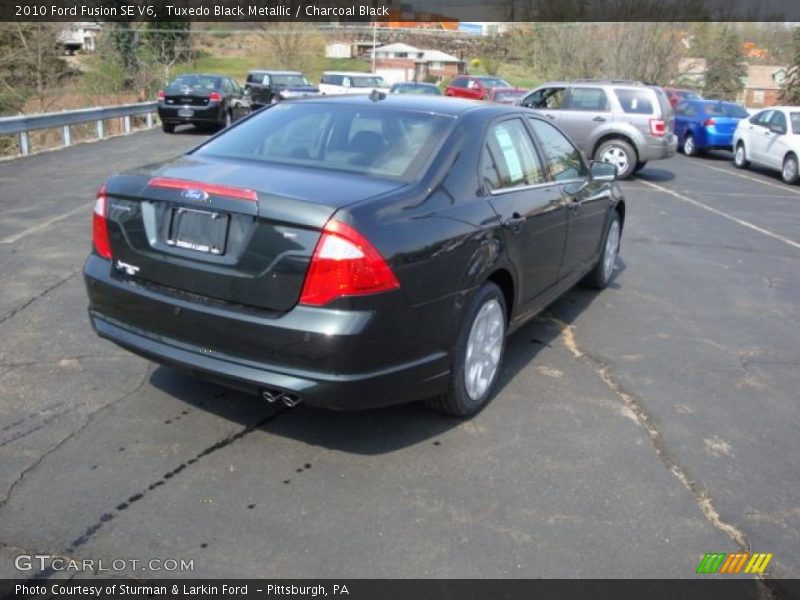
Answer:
[{"left": 0, "top": 131, "right": 800, "bottom": 578}]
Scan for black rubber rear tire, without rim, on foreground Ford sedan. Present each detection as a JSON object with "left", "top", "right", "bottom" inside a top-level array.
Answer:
[{"left": 425, "top": 282, "right": 508, "bottom": 417}]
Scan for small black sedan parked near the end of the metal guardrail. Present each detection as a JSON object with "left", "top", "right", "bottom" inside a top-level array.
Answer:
[{"left": 158, "top": 74, "right": 250, "bottom": 133}]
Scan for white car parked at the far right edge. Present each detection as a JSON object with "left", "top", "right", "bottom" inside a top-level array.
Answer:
[{"left": 733, "top": 106, "right": 800, "bottom": 184}]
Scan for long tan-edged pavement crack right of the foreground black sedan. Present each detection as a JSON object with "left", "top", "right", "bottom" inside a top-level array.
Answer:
[{"left": 550, "top": 316, "right": 750, "bottom": 552}]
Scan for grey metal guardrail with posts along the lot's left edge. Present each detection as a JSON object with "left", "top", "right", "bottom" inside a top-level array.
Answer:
[{"left": 0, "top": 102, "right": 157, "bottom": 155}]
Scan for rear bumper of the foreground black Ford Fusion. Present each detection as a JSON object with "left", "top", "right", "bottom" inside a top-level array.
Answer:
[{"left": 84, "top": 255, "right": 450, "bottom": 410}]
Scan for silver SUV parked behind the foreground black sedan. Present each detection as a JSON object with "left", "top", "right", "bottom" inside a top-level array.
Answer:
[{"left": 519, "top": 80, "right": 676, "bottom": 179}]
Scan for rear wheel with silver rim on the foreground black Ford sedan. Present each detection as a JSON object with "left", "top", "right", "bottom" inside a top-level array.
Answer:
[{"left": 425, "top": 282, "right": 507, "bottom": 417}]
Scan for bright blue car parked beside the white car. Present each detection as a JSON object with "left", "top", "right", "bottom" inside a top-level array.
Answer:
[{"left": 675, "top": 100, "right": 749, "bottom": 156}]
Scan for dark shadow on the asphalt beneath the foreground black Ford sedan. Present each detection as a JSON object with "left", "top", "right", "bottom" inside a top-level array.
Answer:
[{"left": 145, "top": 268, "right": 625, "bottom": 455}]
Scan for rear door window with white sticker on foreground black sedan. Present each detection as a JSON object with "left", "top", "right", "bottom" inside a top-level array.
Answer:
[{"left": 481, "top": 119, "right": 546, "bottom": 190}]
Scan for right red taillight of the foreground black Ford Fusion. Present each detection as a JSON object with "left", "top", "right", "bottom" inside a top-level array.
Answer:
[{"left": 300, "top": 221, "right": 400, "bottom": 306}]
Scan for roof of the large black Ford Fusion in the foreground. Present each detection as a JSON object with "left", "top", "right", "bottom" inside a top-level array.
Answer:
[{"left": 294, "top": 94, "right": 537, "bottom": 117}]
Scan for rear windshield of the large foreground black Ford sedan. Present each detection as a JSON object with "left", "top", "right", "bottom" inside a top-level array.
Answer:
[{"left": 196, "top": 102, "right": 453, "bottom": 181}]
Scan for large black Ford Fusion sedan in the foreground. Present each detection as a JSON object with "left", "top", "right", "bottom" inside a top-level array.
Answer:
[{"left": 84, "top": 93, "right": 625, "bottom": 416}]
